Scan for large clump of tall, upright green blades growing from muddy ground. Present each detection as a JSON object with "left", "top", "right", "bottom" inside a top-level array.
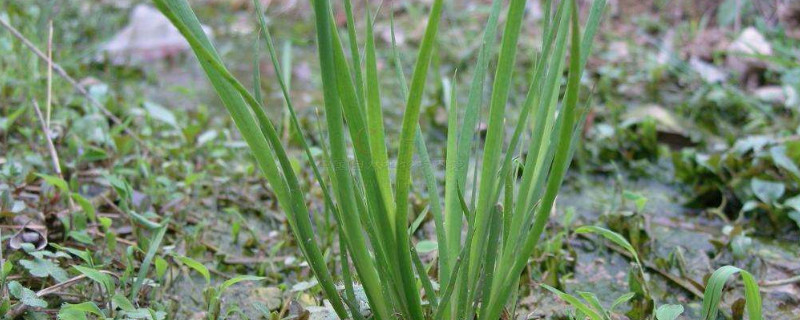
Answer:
[{"left": 155, "top": 0, "right": 605, "bottom": 319}]
